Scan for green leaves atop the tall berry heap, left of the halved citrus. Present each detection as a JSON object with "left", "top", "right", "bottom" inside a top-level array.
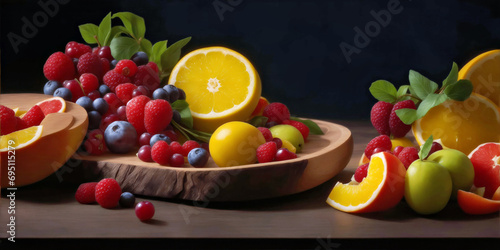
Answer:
[{"left": 78, "top": 12, "right": 191, "bottom": 84}]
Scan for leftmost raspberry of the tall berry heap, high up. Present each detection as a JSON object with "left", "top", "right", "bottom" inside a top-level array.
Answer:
[{"left": 43, "top": 52, "right": 75, "bottom": 82}]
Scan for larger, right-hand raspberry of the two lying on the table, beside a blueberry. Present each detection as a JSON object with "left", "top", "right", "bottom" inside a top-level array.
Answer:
[{"left": 95, "top": 178, "right": 122, "bottom": 208}]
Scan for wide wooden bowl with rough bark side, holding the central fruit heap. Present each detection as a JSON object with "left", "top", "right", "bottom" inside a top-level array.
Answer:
[{"left": 79, "top": 120, "right": 353, "bottom": 201}]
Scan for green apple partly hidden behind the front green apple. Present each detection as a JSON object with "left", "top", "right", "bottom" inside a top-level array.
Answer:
[{"left": 427, "top": 149, "right": 474, "bottom": 198}]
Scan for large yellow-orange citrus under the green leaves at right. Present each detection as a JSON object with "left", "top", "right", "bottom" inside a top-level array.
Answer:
[{"left": 412, "top": 93, "right": 500, "bottom": 155}]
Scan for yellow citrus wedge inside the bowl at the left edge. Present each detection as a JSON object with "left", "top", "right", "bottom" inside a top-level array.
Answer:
[{"left": 0, "top": 125, "right": 43, "bottom": 152}]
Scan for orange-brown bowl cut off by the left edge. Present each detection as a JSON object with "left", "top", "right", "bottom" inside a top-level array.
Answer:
[{"left": 0, "top": 94, "right": 88, "bottom": 187}]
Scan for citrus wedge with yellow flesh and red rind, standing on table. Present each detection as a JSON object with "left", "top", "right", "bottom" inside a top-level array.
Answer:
[{"left": 326, "top": 152, "right": 406, "bottom": 213}]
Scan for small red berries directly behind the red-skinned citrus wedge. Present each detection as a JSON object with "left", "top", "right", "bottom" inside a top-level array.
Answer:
[{"left": 354, "top": 135, "right": 443, "bottom": 182}]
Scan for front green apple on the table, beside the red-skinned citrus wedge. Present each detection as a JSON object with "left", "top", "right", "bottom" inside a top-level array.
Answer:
[{"left": 405, "top": 159, "right": 452, "bottom": 214}]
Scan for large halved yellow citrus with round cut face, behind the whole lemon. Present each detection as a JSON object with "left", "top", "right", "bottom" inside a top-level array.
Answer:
[{"left": 169, "top": 47, "right": 262, "bottom": 132}]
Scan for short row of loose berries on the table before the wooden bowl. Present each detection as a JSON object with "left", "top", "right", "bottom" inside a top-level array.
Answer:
[{"left": 75, "top": 178, "right": 155, "bottom": 221}]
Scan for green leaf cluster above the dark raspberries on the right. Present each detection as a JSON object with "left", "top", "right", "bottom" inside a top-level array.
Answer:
[{"left": 370, "top": 63, "right": 472, "bottom": 124}]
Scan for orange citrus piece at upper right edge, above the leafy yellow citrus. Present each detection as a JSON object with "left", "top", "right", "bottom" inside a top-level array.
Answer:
[{"left": 458, "top": 49, "right": 500, "bottom": 106}]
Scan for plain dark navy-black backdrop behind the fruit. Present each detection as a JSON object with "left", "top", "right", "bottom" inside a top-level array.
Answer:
[{"left": 0, "top": 0, "right": 500, "bottom": 119}]
